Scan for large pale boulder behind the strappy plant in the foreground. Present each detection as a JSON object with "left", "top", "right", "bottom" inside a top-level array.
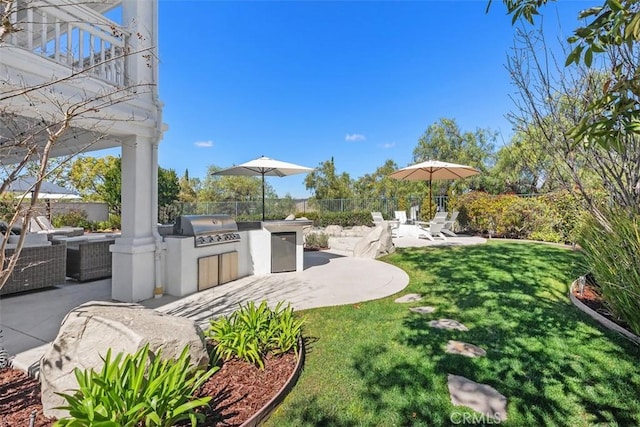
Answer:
[{"left": 40, "top": 301, "right": 209, "bottom": 418}]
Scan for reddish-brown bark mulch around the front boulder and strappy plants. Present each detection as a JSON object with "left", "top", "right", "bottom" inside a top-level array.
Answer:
[{"left": 0, "top": 353, "right": 297, "bottom": 427}]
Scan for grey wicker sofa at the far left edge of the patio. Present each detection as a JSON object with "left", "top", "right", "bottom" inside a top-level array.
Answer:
[{"left": 0, "top": 242, "right": 67, "bottom": 295}]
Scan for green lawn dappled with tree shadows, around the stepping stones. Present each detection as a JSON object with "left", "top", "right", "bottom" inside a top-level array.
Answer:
[{"left": 267, "top": 243, "right": 640, "bottom": 426}]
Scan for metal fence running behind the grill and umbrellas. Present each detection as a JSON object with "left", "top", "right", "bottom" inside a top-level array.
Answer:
[{"left": 159, "top": 196, "right": 447, "bottom": 224}]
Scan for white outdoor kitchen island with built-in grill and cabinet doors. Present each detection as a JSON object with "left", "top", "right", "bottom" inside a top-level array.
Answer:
[{"left": 164, "top": 215, "right": 312, "bottom": 297}]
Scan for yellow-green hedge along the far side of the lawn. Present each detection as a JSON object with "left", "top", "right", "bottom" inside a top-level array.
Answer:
[{"left": 449, "top": 192, "right": 583, "bottom": 243}]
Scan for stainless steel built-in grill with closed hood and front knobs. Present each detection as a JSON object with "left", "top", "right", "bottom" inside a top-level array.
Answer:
[{"left": 174, "top": 214, "right": 240, "bottom": 247}]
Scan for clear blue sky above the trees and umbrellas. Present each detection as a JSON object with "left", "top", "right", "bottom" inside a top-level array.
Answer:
[{"left": 152, "top": 0, "right": 594, "bottom": 197}]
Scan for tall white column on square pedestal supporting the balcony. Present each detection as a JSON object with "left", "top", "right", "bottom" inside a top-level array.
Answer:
[{"left": 111, "top": 0, "right": 163, "bottom": 302}]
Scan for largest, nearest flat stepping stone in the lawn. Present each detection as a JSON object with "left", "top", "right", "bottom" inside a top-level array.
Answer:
[{"left": 447, "top": 374, "right": 507, "bottom": 424}]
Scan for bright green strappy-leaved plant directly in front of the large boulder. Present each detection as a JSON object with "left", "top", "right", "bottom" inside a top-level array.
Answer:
[{"left": 56, "top": 344, "right": 218, "bottom": 427}]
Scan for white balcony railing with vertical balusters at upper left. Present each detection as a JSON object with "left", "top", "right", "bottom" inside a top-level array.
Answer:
[{"left": 3, "top": 0, "right": 129, "bottom": 86}]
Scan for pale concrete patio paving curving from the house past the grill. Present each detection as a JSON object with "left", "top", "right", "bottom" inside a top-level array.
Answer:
[{"left": 0, "top": 236, "right": 484, "bottom": 370}]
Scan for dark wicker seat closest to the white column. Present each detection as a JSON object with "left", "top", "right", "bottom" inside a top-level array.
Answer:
[{"left": 67, "top": 239, "right": 115, "bottom": 282}]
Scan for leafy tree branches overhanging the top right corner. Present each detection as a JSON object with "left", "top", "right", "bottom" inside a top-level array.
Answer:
[{"left": 496, "top": 0, "right": 640, "bottom": 151}]
